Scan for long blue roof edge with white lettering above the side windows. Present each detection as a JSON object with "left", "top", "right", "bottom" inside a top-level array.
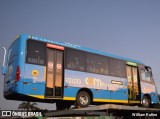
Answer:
[{"left": 20, "top": 34, "right": 144, "bottom": 65}]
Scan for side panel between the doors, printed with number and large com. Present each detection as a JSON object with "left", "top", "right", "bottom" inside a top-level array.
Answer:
[{"left": 64, "top": 70, "right": 128, "bottom": 102}]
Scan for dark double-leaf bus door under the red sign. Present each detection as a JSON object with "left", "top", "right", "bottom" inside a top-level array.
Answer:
[{"left": 45, "top": 44, "right": 64, "bottom": 98}]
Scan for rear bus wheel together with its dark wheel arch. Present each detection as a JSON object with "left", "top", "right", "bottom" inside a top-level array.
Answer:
[{"left": 75, "top": 88, "right": 93, "bottom": 107}]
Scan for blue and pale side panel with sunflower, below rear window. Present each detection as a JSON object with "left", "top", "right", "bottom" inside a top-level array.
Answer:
[{"left": 23, "top": 64, "right": 46, "bottom": 96}]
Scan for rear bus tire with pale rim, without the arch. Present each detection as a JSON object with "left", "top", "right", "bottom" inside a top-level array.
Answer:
[{"left": 76, "top": 91, "right": 91, "bottom": 107}]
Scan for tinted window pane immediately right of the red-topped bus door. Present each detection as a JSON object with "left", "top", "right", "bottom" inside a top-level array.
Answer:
[{"left": 66, "top": 49, "right": 85, "bottom": 71}]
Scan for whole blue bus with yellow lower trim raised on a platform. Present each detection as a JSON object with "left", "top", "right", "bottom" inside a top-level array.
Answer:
[{"left": 2, "top": 34, "right": 159, "bottom": 109}]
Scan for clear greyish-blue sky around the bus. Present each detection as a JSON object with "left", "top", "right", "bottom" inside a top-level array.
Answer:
[{"left": 0, "top": 0, "right": 160, "bottom": 110}]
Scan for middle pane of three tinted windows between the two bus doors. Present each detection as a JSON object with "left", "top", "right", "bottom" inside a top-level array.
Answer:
[{"left": 87, "top": 53, "right": 108, "bottom": 74}]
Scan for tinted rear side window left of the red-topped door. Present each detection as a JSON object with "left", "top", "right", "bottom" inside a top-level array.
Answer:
[{"left": 26, "top": 40, "right": 46, "bottom": 65}]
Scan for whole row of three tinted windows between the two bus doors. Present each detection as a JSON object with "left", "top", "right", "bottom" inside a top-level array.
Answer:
[{"left": 65, "top": 49, "right": 126, "bottom": 78}]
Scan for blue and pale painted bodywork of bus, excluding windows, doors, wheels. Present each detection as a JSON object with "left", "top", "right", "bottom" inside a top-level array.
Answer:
[{"left": 2, "top": 34, "right": 158, "bottom": 103}]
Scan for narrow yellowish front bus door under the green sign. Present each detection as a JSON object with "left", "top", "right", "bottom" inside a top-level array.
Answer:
[{"left": 126, "top": 66, "right": 140, "bottom": 103}]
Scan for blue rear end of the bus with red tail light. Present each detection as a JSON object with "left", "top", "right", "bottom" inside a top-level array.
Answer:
[{"left": 2, "top": 37, "right": 23, "bottom": 100}]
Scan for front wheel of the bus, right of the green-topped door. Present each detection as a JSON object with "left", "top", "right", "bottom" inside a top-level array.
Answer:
[{"left": 142, "top": 94, "right": 151, "bottom": 108}]
